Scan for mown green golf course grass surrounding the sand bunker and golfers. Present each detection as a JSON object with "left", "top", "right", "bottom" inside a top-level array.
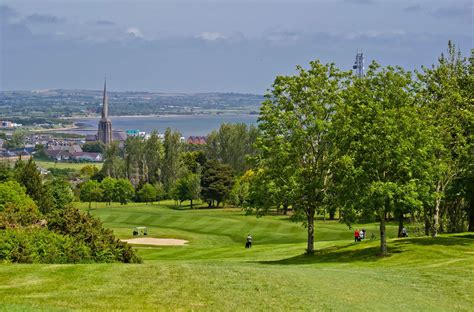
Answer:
[{"left": 0, "top": 202, "right": 474, "bottom": 311}]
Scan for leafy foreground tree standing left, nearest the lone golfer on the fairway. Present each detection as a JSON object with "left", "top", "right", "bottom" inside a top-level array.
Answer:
[{"left": 252, "top": 61, "right": 346, "bottom": 254}]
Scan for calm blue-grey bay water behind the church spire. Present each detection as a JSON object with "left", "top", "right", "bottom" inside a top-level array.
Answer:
[{"left": 65, "top": 114, "right": 258, "bottom": 137}]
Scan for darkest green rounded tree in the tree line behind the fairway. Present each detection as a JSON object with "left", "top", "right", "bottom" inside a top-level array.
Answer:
[{"left": 201, "top": 160, "right": 234, "bottom": 206}]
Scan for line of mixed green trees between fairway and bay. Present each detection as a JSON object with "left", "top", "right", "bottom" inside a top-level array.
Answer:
[{"left": 80, "top": 124, "right": 258, "bottom": 207}]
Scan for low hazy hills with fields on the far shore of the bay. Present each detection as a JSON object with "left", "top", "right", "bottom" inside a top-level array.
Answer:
[{"left": 0, "top": 89, "right": 264, "bottom": 117}]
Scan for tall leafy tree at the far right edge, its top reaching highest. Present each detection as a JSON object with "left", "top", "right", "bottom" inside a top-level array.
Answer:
[{"left": 418, "top": 42, "right": 474, "bottom": 236}]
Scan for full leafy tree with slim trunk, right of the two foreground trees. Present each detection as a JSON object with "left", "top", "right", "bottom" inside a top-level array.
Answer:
[{"left": 334, "top": 62, "right": 432, "bottom": 255}]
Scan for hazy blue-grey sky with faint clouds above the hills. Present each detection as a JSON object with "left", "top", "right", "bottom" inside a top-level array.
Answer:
[{"left": 0, "top": 0, "right": 474, "bottom": 94}]
